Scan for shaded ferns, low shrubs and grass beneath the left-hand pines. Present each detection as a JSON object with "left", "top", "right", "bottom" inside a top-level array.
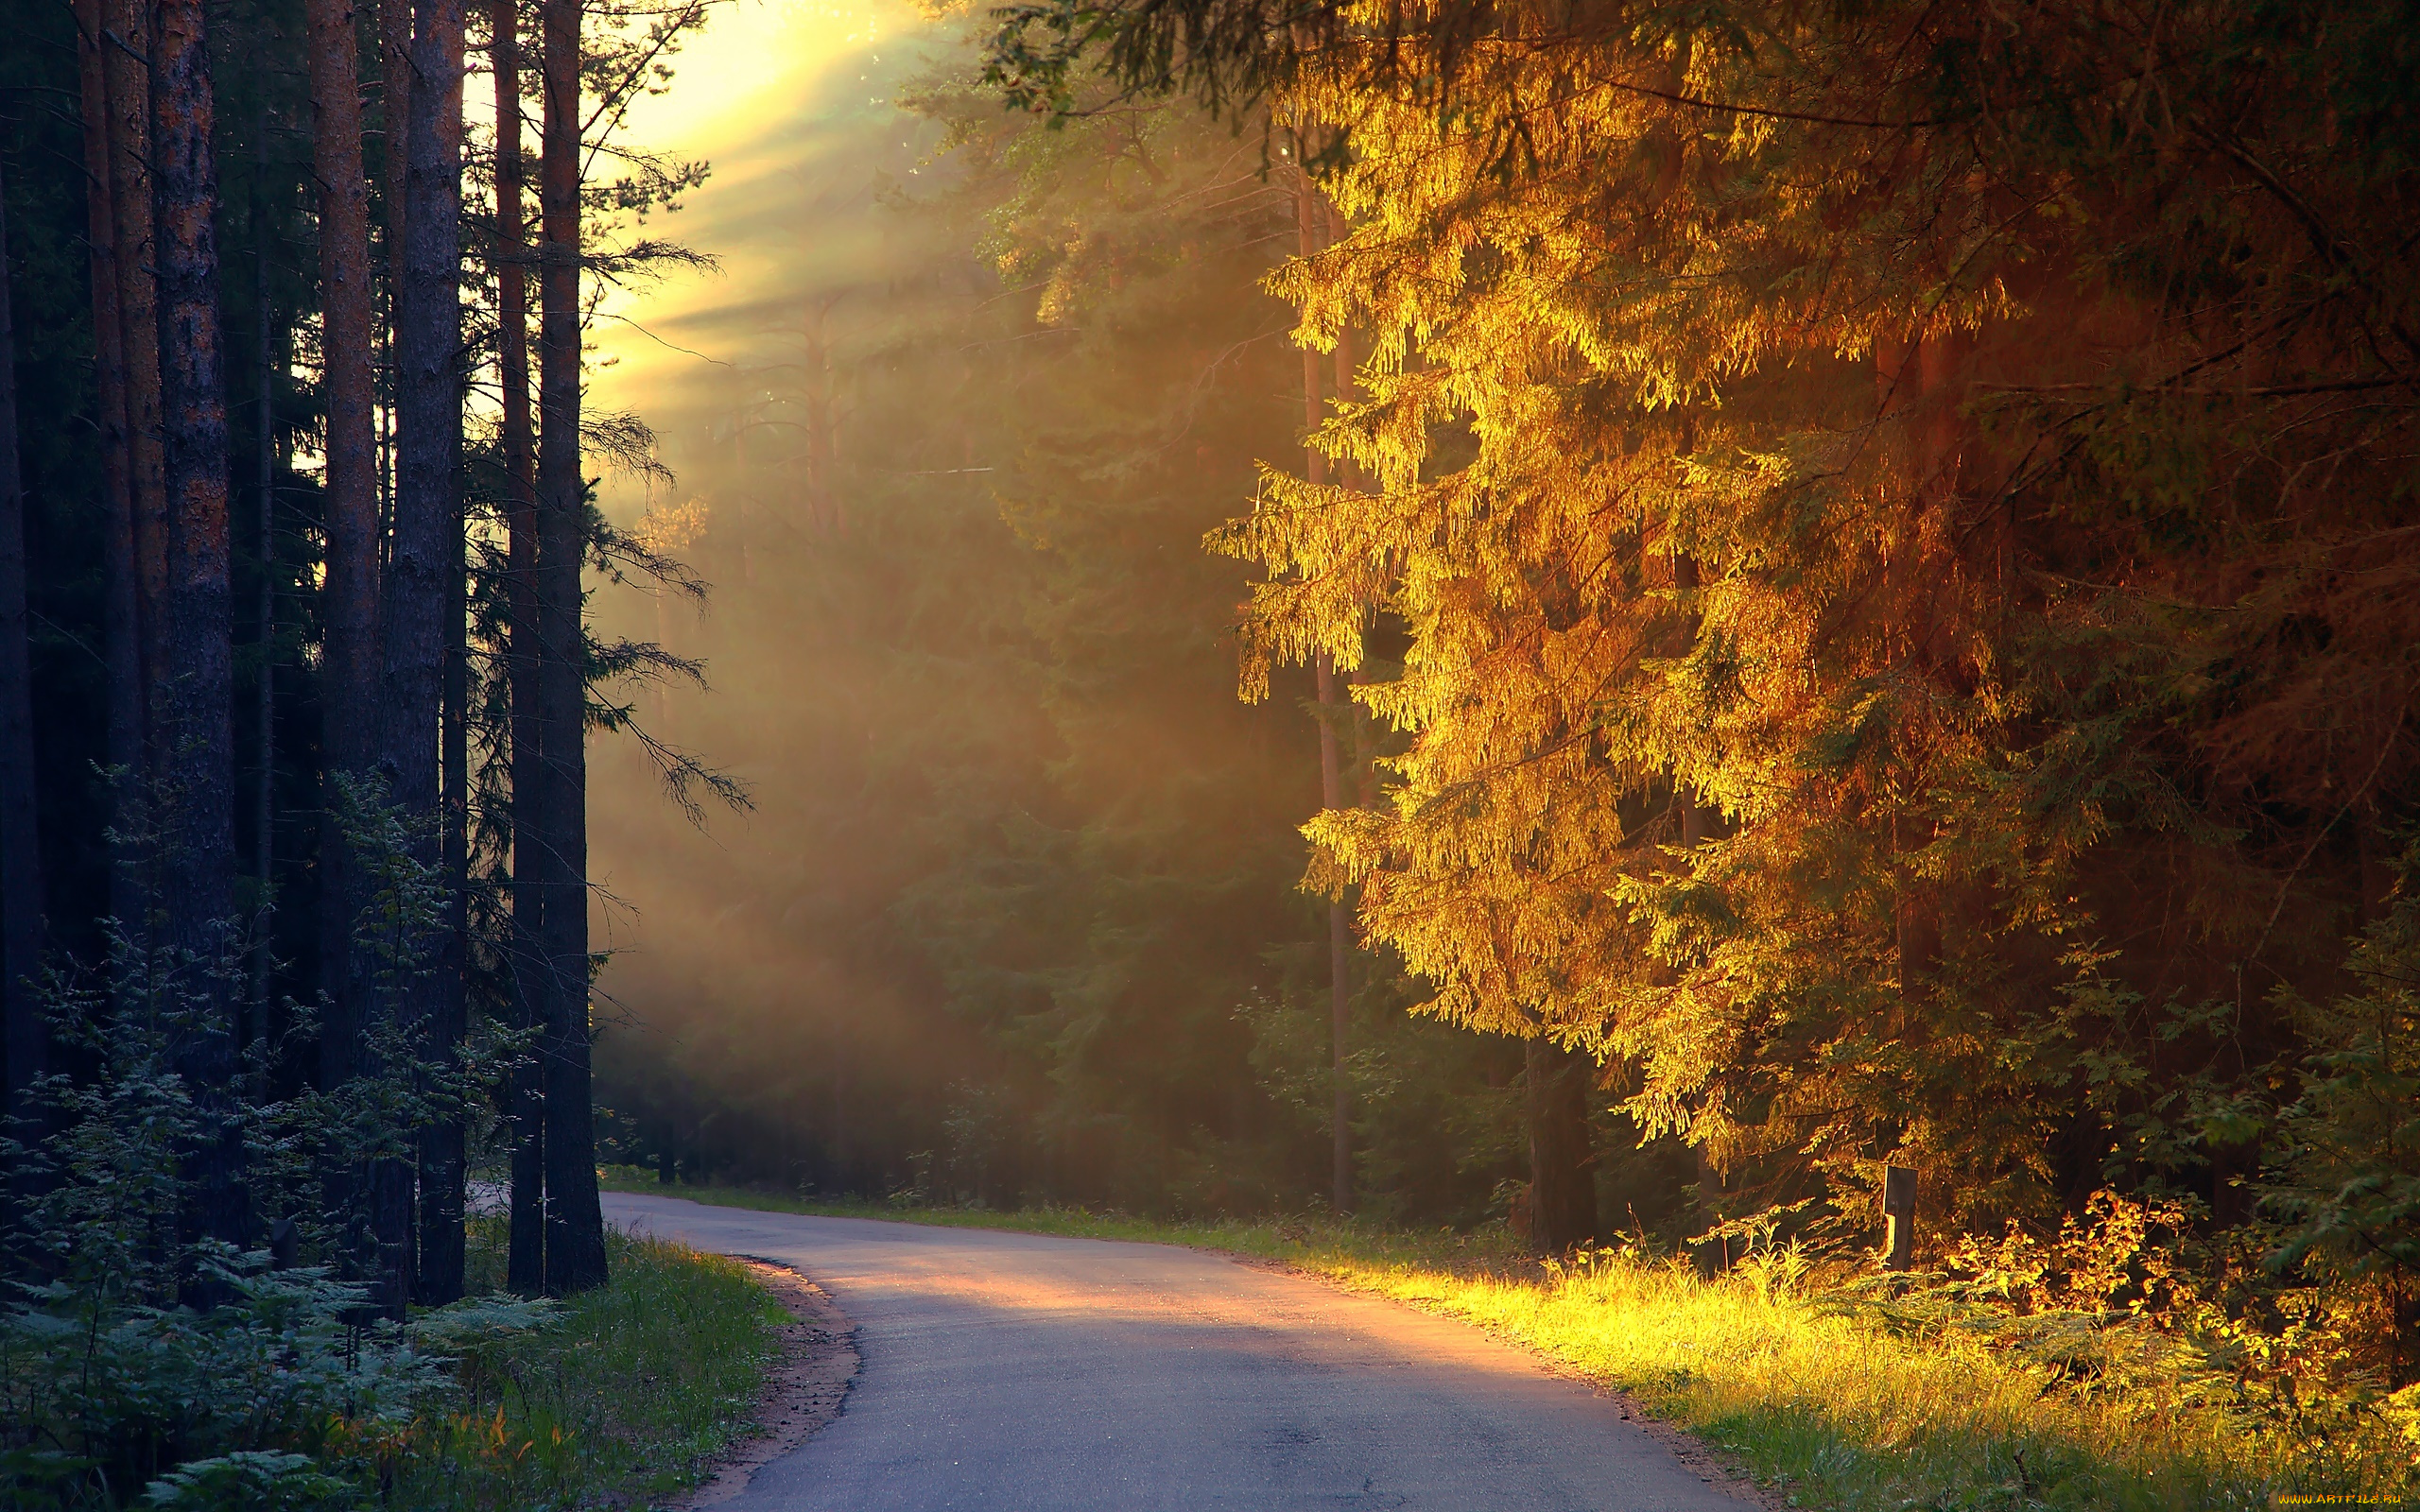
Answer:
[{"left": 0, "top": 1214, "right": 782, "bottom": 1512}]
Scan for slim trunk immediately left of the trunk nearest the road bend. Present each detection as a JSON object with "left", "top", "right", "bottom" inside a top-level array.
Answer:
[{"left": 489, "top": 0, "right": 547, "bottom": 1297}]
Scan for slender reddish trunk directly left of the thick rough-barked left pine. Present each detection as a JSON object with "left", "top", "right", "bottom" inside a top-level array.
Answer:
[{"left": 102, "top": 0, "right": 169, "bottom": 802}]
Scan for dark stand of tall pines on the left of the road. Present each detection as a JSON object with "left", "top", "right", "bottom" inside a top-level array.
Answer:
[{"left": 0, "top": 0, "right": 729, "bottom": 1314}]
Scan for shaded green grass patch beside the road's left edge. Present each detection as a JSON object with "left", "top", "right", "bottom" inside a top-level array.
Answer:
[{"left": 385, "top": 1219, "right": 784, "bottom": 1512}]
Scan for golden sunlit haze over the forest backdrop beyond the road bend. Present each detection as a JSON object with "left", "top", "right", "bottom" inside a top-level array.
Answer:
[{"left": 578, "top": 0, "right": 1558, "bottom": 1219}]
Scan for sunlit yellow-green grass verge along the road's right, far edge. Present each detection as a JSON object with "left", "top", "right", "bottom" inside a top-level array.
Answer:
[{"left": 610, "top": 1174, "right": 2420, "bottom": 1512}]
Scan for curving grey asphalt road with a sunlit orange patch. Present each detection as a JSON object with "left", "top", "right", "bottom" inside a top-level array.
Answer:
[{"left": 605, "top": 1193, "right": 1747, "bottom": 1512}]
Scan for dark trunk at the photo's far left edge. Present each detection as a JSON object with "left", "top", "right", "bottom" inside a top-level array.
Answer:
[{"left": 0, "top": 159, "right": 51, "bottom": 1191}]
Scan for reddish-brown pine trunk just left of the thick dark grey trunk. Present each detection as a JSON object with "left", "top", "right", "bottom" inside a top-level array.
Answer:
[{"left": 305, "top": 0, "right": 377, "bottom": 1091}]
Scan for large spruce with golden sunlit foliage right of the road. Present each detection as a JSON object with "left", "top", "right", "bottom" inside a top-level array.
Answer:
[{"left": 1213, "top": 5, "right": 2420, "bottom": 1258}]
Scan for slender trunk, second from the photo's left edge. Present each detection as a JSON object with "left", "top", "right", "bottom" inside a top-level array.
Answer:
[{"left": 75, "top": 0, "right": 143, "bottom": 929}]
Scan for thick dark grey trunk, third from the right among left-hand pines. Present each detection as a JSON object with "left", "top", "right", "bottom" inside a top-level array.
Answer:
[{"left": 396, "top": 0, "right": 462, "bottom": 1301}]
